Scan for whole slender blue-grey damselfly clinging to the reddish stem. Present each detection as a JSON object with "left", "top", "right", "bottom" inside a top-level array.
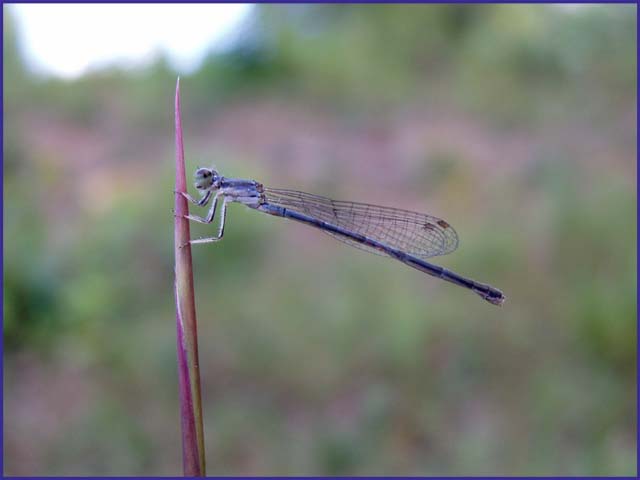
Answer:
[{"left": 175, "top": 167, "right": 505, "bottom": 305}]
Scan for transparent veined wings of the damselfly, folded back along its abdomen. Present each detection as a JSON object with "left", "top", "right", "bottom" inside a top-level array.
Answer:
[{"left": 264, "top": 188, "right": 458, "bottom": 259}]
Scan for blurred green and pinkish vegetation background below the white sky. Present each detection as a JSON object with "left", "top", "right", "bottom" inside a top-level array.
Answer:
[{"left": 3, "top": 5, "right": 637, "bottom": 475}]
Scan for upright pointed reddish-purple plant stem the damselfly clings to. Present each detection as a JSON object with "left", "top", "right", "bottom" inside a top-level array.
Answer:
[{"left": 174, "top": 78, "right": 206, "bottom": 477}]
